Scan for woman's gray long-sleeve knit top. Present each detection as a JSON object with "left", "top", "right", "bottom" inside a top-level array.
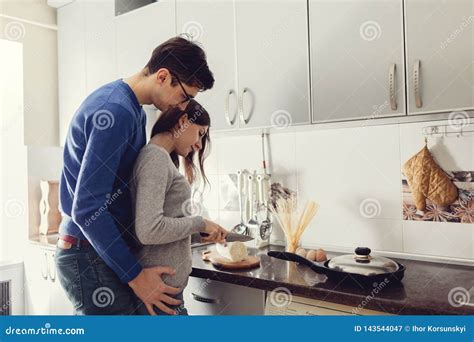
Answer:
[{"left": 131, "top": 143, "right": 205, "bottom": 289}]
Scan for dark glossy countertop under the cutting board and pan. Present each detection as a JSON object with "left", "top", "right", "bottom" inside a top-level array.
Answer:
[{"left": 191, "top": 246, "right": 474, "bottom": 315}]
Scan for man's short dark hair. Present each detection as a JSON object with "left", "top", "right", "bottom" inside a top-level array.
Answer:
[{"left": 145, "top": 37, "right": 214, "bottom": 91}]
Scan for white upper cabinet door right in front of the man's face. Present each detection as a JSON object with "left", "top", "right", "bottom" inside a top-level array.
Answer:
[{"left": 176, "top": 0, "right": 238, "bottom": 130}]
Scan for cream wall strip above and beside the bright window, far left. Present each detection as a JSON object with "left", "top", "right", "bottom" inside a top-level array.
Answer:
[{"left": 0, "top": 0, "right": 58, "bottom": 146}]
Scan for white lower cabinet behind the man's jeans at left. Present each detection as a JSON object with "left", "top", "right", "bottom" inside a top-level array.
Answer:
[{"left": 25, "top": 244, "right": 74, "bottom": 315}]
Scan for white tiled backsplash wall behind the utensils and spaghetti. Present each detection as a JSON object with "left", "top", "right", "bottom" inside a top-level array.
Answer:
[{"left": 204, "top": 121, "right": 474, "bottom": 260}]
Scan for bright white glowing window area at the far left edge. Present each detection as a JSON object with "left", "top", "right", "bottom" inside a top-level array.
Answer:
[{"left": 0, "top": 39, "right": 28, "bottom": 260}]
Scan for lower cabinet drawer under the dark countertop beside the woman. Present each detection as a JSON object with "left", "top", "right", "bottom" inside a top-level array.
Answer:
[{"left": 184, "top": 277, "right": 265, "bottom": 316}]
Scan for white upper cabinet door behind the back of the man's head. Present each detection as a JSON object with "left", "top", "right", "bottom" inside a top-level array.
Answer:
[{"left": 115, "top": 0, "right": 176, "bottom": 78}]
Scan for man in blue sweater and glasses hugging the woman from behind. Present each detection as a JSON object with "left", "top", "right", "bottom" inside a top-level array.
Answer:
[{"left": 56, "top": 37, "right": 214, "bottom": 315}]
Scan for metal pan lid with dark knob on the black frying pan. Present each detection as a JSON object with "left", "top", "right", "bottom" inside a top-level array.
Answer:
[{"left": 328, "top": 247, "right": 399, "bottom": 276}]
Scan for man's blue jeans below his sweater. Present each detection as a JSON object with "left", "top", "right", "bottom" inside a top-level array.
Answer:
[{"left": 55, "top": 245, "right": 139, "bottom": 315}]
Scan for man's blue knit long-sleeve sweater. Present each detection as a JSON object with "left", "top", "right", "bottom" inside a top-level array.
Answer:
[{"left": 60, "top": 80, "right": 146, "bottom": 283}]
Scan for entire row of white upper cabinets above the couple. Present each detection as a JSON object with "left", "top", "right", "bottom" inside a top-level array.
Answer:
[{"left": 56, "top": 0, "right": 474, "bottom": 143}]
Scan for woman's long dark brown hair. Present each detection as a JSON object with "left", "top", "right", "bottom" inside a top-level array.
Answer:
[{"left": 151, "top": 100, "right": 211, "bottom": 184}]
